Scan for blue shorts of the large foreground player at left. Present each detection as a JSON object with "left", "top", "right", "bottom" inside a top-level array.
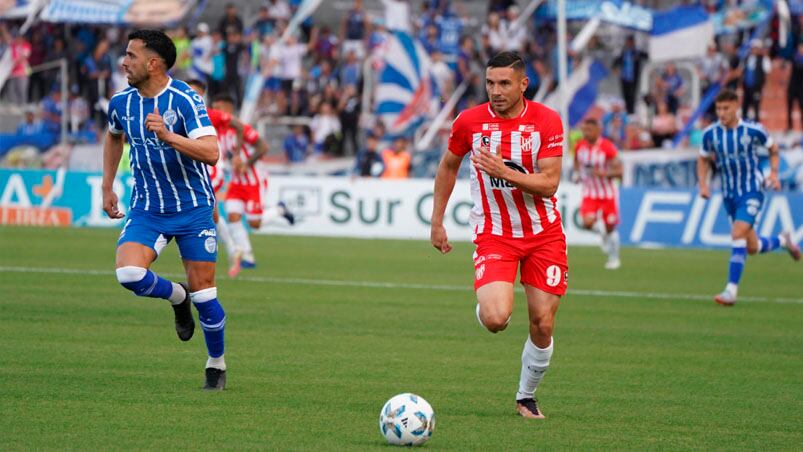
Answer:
[{"left": 117, "top": 207, "right": 217, "bottom": 262}]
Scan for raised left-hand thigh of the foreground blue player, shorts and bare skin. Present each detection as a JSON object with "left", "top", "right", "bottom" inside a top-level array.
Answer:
[{"left": 115, "top": 212, "right": 170, "bottom": 268}]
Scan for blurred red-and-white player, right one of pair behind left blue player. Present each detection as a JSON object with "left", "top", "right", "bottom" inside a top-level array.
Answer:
[{"left": 212, "top": 94, "right": 295, "bottom": 268}]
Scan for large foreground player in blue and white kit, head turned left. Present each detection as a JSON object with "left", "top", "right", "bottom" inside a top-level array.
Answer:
[{"left": 103, "top": 30, "right": 226, "bottom": 389}]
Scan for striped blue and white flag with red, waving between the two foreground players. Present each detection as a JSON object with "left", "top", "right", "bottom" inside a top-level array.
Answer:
[{"left": 374, "top": 31, "right": 438, "bottom": 136}]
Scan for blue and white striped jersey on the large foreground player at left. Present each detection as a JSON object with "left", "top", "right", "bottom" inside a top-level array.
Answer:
[{"left": 109, "top": 78, "right": 216, "bottom": 213}]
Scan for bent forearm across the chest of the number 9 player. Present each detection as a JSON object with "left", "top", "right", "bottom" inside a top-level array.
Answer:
[{"left": 471, "top": 148, "right": 562, "bottom": 198}]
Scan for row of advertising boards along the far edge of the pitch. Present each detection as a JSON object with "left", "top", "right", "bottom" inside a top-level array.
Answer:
[{"left": 0, "top": 169, "right": 803, "bottom": 248}]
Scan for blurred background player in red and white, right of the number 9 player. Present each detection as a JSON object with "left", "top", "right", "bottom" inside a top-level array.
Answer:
[{"left": 574, "top": 119, "right": 622, "bottom": 270}]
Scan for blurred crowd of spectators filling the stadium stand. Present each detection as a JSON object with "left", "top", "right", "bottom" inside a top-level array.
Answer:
[{"left": 0, "top": 0, "right": 803, "bottom": 175}]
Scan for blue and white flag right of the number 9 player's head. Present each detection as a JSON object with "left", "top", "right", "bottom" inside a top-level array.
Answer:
[{"left": 544, "top": 58, "right": 608, "bottom": 127}]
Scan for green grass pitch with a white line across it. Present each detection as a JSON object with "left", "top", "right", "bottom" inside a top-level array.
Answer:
[{"left": 0, "top": 227, "right": 803, "bottom": 450}]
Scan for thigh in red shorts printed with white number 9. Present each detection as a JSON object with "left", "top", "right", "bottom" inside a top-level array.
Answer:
[{"left": 521, "top": 228, "right": 569, "bottom": 296}]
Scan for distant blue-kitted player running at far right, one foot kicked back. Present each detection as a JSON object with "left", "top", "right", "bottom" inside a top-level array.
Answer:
[{"left": 697, "top": 90, "right": 800, "bottom": 306}]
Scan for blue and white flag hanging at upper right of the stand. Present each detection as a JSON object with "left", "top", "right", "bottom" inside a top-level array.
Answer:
[{"left": 650, "top": 5, "right": 714, "bottom": 61}]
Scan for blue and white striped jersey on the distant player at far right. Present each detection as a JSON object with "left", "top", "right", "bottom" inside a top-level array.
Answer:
[{"left": 700, "top": 119, "right": 772, "bottom": 198}]
